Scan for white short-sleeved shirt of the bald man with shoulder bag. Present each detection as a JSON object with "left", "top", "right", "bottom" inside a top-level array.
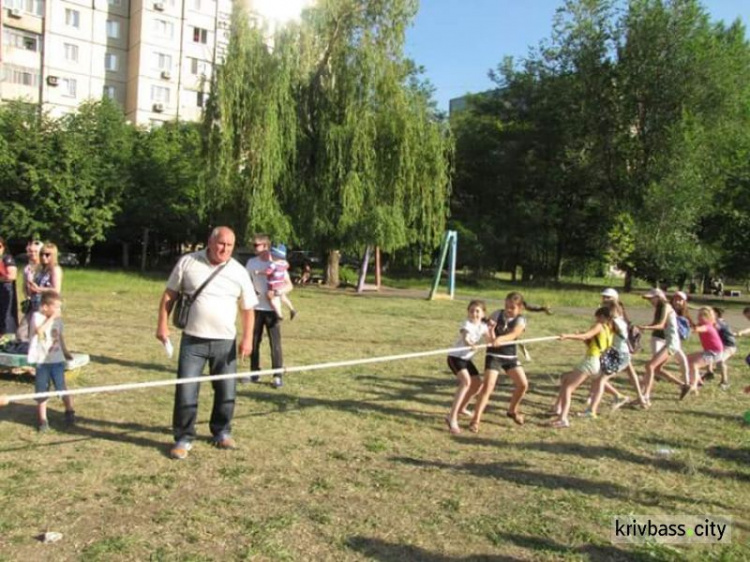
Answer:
[{"left": 167, "top": 250, "right": 258, "bottom": 340}]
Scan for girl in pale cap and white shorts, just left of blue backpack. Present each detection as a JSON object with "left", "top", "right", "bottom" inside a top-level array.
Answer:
[{"left": 639, "top": 289, "right": 691, "bottom": 404}]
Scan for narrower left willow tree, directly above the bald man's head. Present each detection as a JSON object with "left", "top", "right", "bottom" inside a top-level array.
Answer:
[{"left": 206, "top": 3, "right": 298, "bottom": 241}]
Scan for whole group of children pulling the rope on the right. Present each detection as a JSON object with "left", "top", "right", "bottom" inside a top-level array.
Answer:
[{"left": 445, "top": 288, "right": 750, "bottom": 435}]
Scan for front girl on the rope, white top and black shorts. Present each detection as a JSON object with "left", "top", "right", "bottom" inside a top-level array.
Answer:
[{"left": 445, "top": 300, "right": 489, "bottom": 435}]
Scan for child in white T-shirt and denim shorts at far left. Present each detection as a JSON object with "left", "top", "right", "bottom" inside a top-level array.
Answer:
[{"left": 28, "top": 291, "right": 75, "bottom": 432}]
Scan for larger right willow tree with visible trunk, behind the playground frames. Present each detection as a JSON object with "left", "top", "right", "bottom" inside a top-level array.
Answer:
[{"left": 288, "top": 0, "right": 452, "bottom": 285}]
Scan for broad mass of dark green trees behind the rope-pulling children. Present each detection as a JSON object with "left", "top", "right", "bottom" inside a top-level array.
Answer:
[{"left": 453, "top": 0, "right": 750, "bottom": 280}]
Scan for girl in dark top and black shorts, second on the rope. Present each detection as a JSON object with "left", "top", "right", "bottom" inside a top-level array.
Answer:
[{"left": 459, "top": 291, "right": 529, "bottom": 433}]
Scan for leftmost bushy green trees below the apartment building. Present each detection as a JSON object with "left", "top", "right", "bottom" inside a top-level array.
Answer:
[{"left": 0, "top": 100, "right": 132, "bottom": 250}]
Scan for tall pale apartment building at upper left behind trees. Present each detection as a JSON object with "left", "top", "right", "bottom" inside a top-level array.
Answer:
[{"left": 0, "top": 0, "right": 257, "bottom": 126}]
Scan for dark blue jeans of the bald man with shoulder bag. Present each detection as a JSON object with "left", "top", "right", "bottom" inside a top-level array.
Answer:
[{"left": 172, "top": 334, "right": 237, "bottom": 442}]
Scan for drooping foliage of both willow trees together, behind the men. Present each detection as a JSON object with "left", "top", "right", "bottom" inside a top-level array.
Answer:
[{"left": 203, "top": 0, "right": 451, "bottom": 276}]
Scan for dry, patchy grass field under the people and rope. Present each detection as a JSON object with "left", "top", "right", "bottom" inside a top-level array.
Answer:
[{"left": 0, "top": 270, "right": 750, "bottom": 562}]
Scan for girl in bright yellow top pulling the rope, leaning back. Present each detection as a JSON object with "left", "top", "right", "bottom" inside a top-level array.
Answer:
[{"left": 550, "top": 304, "right": 614, "bottom": 429}]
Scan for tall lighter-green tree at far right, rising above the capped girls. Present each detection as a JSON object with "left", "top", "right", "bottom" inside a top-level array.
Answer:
[{"left": 619, "top": 0, "right": 747, "bottom": 282}]
